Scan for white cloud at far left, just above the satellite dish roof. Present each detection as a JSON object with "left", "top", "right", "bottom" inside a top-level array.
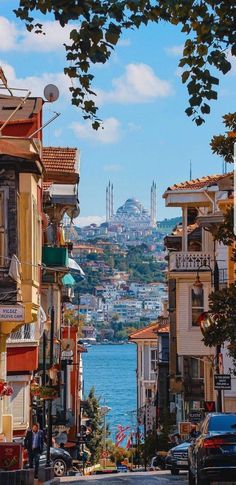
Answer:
[{"left": 0, "top": 60, "right": 71, "bottom": 97}]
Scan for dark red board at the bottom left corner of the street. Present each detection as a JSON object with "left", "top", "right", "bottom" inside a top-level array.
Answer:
[{"left": 0, "top": 443, "right": 23, "bottom": 471}]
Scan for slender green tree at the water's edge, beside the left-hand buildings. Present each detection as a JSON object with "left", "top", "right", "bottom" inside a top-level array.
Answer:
[{"left": 84, "top": 387, "right": 103, "bottom": 464}]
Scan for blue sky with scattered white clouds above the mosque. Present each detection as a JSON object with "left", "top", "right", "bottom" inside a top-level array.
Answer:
[{"left": 0, "top": 0, "right": 236, "bottom": 226}]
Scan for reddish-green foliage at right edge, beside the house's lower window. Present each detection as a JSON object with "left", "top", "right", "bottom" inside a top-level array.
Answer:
[{"left": 203, "top": 283, "right": 236, "bottom": 370}]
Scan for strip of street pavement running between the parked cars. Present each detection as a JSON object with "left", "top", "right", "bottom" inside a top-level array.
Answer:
[{"left": 60, "top": 471, "right": 187, "bottom": 485}]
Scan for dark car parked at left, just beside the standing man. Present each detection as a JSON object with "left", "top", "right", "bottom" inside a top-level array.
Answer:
[{"left": 39, "top": 448, "right": 73, "bottom": 477}]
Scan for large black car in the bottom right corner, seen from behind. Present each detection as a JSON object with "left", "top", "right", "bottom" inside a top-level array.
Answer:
[{"left": 188, "top": 413, "right": 236, "bottom": 485}]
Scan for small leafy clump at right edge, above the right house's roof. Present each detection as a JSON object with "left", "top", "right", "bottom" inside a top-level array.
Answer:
[{"left": 210, "top": 113, "right": 236, "bottom": 163}]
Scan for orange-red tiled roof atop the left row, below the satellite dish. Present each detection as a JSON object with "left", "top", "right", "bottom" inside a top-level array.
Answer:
[{"left": 42, "top": 147, "right": 78, "bottom": 173}]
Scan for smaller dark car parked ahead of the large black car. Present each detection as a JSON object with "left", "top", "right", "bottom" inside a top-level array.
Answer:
[{"left": 166, "top": 441, "right": 190, "bottom": 475}]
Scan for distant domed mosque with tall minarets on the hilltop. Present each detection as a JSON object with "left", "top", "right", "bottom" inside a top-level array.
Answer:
[{"left": 106, "top": 182, "right": 157, "bottom": 230}]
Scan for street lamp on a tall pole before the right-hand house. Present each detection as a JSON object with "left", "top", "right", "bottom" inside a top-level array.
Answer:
[{"left": 193, "top": 259, "right": 222, "bottom": 412}]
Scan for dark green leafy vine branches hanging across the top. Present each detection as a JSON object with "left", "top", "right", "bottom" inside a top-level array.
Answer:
[{"left": 14, "top": 0, "right": 236, "bottom": 129}]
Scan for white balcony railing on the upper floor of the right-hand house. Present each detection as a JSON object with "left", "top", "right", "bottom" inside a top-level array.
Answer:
[{"left": 169, "top": 251, "right": 214, "bottom": 271}]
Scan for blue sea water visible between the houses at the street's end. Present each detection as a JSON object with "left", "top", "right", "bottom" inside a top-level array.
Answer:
[{"left": 83, "top": 344, "right": 137, "bottom": 440}]
